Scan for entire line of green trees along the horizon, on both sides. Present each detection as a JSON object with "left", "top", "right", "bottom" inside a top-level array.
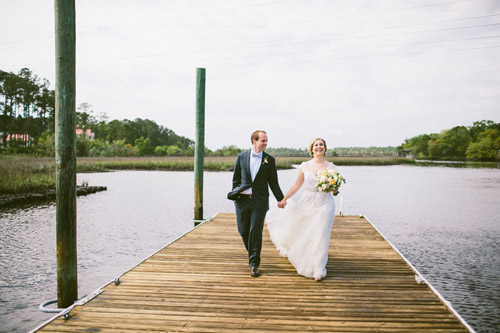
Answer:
[{"left": 0, "top": 68, "right": 500, "bottom": 160}]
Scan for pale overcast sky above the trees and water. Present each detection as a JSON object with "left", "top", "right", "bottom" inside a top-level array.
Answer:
[{"left": 0, "top": 0, "right": 500, "bottom": 150}]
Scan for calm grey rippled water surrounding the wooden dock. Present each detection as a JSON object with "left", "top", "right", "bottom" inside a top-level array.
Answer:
[{"left": 0, "top": 166, "right": 500, "bottom": 332}]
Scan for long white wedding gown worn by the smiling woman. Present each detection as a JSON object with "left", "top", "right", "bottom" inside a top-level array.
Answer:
[{"left": 266, "top": 162, "right": 335, "bottom": 278}]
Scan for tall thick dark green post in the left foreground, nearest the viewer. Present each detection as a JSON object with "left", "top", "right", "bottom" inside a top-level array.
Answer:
[{"left": 54, "top": 0, "right": 78, "bottom": 308}]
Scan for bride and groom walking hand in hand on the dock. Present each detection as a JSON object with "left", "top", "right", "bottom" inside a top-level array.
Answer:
[{"left": 228, "top": 131, "right": 335, "bottom": 281}]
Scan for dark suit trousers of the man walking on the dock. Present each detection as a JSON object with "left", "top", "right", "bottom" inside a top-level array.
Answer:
[{"left": 234, "top": 196, "right": 267, "bottom": 267}]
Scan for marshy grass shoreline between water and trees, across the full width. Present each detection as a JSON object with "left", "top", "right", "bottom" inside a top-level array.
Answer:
[{"left": 0, "top": 155, "right": 499, "bottom": 208}]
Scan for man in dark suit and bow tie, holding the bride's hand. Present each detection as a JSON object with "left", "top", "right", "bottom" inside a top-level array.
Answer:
[{"left": 228, "top": 131, "right": 284, "bottom": 277}]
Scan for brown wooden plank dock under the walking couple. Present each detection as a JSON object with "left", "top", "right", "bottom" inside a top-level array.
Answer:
[{"left": 38, "top": 214, "right": 472, "bottom": 332}]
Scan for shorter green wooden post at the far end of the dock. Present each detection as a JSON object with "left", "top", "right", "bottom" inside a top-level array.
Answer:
[{"left": 194, "top": 68, "right": 206, "bottom": 226}]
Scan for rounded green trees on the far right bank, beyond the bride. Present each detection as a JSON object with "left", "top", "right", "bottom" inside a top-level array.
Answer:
[{"left": 399, "top": 120, "right": 500, "bottom": 161}]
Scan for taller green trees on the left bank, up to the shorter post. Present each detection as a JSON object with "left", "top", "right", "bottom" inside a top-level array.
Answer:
[{"left": 0, "top": 68, "right": 194, "bottom": 156}]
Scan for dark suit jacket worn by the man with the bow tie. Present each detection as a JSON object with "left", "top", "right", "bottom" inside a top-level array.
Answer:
[{"left": 228, "top": 150, "right": 284, "bottom": 210}]
